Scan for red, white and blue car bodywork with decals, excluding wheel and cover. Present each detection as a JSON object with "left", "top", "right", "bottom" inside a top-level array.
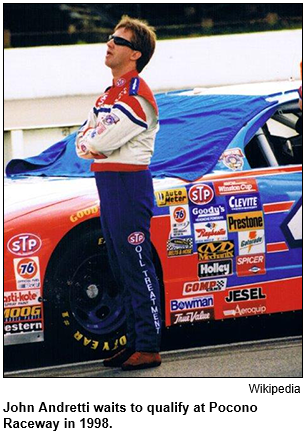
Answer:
[{"left": 4, "top": 85, "right": 302, "bottom": 345}]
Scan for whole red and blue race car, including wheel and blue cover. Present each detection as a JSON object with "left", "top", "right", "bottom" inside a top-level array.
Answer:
[{"left": 4, "top": 82, "right": 302, "bottom": 358}]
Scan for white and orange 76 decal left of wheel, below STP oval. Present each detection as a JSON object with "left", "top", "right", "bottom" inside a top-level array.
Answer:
[{"left": 14, "top": 257, "right": 41, "bottom": 289}]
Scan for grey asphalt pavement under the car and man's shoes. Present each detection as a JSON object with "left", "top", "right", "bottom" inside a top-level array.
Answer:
[{"left": 4, "top": 336, "right": 303, "bottom": 378}]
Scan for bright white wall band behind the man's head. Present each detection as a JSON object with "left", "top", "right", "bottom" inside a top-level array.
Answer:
[{"left": 4, "top": 30, "right": 302, "bottom": 100}]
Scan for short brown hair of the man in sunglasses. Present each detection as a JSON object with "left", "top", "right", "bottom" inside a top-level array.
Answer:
[{"left": 115, "top": 15, "right": 156, "bottom": 73}]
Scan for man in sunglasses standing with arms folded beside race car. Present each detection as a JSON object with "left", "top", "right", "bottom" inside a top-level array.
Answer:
[{"left": 76, "top": 16, "right": 161, "bottom": 370}]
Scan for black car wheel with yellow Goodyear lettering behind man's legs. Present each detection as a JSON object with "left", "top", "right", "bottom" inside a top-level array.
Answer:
[{"left": 44, "top": 225, "right": 126, "bottom": 360}]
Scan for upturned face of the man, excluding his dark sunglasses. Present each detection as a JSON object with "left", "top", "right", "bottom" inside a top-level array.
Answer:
[{"left": 105, "top": 27, "right": 135, "bottom": 69}]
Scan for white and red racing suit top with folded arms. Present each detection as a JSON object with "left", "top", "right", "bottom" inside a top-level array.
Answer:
[{"left": 76, "top": 70, "right": 159, "bottom": 172}]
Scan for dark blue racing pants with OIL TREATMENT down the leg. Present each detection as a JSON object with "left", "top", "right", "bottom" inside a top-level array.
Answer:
[{"left": 95, "top": 170, "right": 161, "bottom": 352}]
